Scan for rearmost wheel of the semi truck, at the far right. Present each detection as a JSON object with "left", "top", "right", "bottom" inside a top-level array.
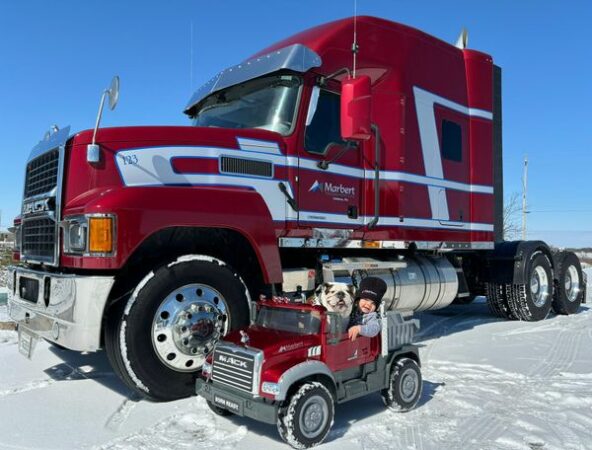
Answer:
[{"left": 552, "top": 252, "right": 585, "bottom": 314}]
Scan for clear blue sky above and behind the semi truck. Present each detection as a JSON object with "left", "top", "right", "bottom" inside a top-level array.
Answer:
[{"left": 0, "top": 0, "right": 592, "bottom": 246}]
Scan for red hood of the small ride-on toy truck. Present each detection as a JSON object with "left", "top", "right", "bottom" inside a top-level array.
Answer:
[{"left": 224, "top": 326, "right": 320, "bottom": 359}]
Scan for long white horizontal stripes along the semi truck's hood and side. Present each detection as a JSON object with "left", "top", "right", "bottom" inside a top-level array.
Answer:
[{"left": 115, "top": 141, "right": 493, "bottom": 231}]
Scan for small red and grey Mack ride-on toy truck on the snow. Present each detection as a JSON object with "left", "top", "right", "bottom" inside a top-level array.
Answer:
[{"left": 196, "top": 300, "right": 422, "bottom": 448}]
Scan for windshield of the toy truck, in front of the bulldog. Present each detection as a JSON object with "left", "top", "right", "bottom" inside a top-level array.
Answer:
[{"left": 256, "top": 306, "right": 321, "bottom": 334}]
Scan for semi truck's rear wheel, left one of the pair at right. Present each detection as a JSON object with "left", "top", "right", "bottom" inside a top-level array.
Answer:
[{"left": 506, "top": 251, "right": 553, "bottom": 322}]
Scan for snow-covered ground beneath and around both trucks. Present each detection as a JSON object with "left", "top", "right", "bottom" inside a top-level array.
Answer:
[{"left": 0, "top": 269, "right": 592, "bottom": 450}]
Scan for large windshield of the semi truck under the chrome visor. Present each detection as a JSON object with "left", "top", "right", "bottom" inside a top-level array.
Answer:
[{"left": 193, "top": 75, "right": 302, "bottom": 135}]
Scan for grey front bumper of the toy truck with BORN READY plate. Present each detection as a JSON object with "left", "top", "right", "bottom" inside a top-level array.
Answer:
[{"left": 195, "top": 378, "right": 278, "bottom": 425}]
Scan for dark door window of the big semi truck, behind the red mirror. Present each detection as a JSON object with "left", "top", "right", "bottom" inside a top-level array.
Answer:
[{"left": 304, "top": 89, "right": 345, "bottom": 155}]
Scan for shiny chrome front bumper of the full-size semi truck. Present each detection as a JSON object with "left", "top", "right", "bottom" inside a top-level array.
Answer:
[{"left": 8, "top": 267, "right": 115, "bottom": 351}]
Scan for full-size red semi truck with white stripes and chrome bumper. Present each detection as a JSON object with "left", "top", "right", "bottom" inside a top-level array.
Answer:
[{"left": 9, "top": 17, "right": 585, "bottom": 400}]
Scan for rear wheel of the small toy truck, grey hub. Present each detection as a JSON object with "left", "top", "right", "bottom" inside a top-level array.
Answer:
[{"left": 380, "top": 358, "right": 423, "bottom": 412}]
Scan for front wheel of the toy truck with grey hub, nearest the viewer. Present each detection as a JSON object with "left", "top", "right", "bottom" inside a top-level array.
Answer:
[{"left": 277, "top": 382, "right": 335, "bottom": 448}]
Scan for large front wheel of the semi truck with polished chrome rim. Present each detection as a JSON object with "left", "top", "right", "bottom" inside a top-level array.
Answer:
[{"left": 105, "top": 259, "right": 249, "bottom": 401}]
